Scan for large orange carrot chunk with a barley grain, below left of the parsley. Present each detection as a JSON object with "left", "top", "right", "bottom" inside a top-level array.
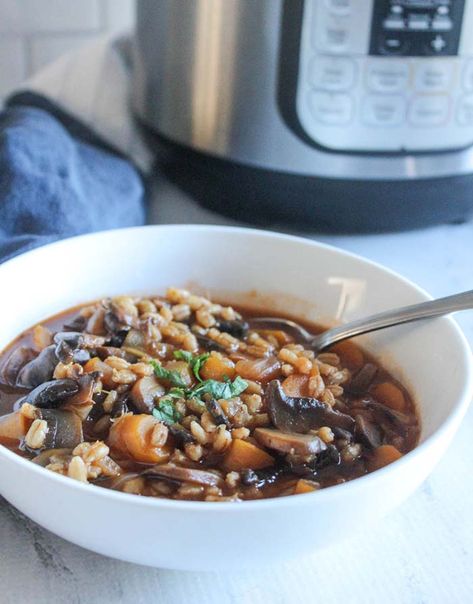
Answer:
[{"left": 108, "top": 413, "right": 170, "bottom": 463}]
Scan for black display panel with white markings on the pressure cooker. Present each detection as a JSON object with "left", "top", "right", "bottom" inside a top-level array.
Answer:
[{"left": 370, "top": 0, "right": 464, "bottom": 57}]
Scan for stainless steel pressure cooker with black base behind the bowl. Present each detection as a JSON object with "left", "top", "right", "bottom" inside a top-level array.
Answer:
[{"left": 133, "top": 0, "right": 473, "bottom": 231}]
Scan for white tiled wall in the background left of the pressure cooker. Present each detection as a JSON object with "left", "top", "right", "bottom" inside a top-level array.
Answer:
[{"left": 0, "top": 0, "right": 134, "bottom": 99}]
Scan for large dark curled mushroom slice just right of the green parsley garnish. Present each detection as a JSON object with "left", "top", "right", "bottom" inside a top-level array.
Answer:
[{"left": 266, "top": 380, "right": 355, "bottom": 433}]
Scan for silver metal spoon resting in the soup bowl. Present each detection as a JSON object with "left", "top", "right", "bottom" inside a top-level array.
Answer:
[{"left": 250, "top": 290, "right": 473, "bottom": 352}]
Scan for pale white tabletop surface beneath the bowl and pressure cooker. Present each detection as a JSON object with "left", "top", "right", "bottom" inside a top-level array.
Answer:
[{"left": 0, "top": 181, "right": 473, "bottom": 604}]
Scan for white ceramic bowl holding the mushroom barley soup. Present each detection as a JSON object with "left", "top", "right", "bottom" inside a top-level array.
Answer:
[{"left": 0, "top": 226, "right": 472, "bottom": 570}]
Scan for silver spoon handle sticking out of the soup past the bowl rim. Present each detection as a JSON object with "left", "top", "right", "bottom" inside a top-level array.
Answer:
[{"left": 312, "top": 290, "right": 473, "bottom": 350}]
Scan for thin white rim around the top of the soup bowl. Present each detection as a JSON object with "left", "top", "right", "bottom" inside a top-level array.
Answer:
[{"left": 0, "top": 224, "right": 473, "bottom": 514}]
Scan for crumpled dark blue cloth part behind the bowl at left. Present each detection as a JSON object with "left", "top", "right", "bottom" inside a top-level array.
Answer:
[{"left": 0, "top": 94, "right": 145, "bottom": 262}]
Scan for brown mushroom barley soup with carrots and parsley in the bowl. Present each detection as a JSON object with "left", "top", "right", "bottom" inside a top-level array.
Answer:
[{"left": 0, "top": 288, "right": 419, "bottom": 501}]
